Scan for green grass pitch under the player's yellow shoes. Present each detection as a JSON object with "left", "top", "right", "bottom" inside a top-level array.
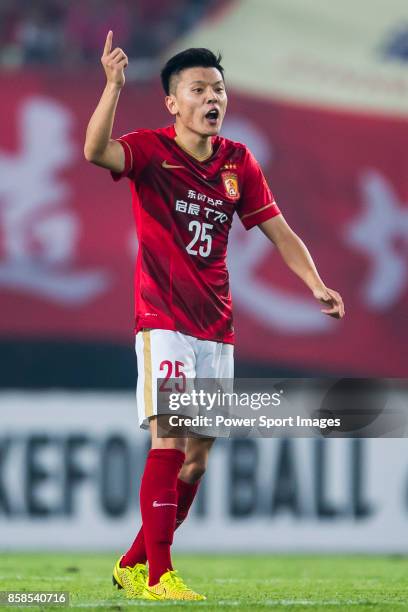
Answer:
[{"left": 0, "top": 553, "right": 408, "bottom": 612}]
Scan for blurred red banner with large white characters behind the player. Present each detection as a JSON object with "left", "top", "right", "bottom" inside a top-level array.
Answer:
[{"left": 0, "top": 73, "right": 408, "bottom": 377}]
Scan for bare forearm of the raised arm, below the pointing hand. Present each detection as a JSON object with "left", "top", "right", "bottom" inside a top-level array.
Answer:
[{"left": 84, "top": 83, "right": 121, "bottom": 161}]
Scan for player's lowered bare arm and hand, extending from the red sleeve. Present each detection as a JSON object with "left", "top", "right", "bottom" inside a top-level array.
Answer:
[{"left": 259, "top": 215, "right": 345, "bottom": 319}]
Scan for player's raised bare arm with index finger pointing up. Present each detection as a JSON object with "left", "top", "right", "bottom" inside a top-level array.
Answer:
[{"left": 84, "top": 30, "right": 128, "bottom": 172}]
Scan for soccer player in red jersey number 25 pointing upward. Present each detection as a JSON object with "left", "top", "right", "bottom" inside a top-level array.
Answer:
[{"left": 84, "top": 31, "right": 344, "bottom": 600}]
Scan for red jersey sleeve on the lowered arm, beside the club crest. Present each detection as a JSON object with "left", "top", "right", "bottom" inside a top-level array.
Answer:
[{"left": 237, "top": 149, "right": 280, "bottom": 230}]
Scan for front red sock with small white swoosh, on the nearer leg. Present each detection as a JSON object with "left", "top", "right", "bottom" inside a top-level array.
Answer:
[{"left": 140, "top": 448, "right": 185, "bottom": 585}]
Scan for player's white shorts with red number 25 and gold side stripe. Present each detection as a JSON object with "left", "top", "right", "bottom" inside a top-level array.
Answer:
[{"left": 136, "top": 329, "right": 234, "bottom": 429}]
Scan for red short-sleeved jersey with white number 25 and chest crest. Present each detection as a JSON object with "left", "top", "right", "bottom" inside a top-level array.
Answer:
[{"left": 112, "top": 126, "right": 280, "bottom": 343}]
